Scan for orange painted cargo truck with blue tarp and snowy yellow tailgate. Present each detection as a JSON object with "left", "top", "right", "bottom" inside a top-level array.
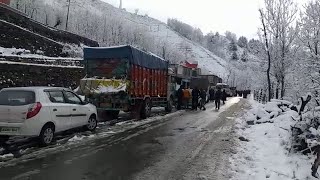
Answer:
[{"left": 78, "top": 46, "right": 173, "bottom": 118}]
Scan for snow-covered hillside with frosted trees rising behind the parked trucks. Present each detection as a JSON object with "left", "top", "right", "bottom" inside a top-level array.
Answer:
[{"left": 7, "top": 0, "right": 262, "bottom": 88}]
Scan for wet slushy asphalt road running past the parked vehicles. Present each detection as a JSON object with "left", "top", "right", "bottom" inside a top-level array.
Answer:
[{"left": 0, "top": 98, "right": 248, "bottom": 180}]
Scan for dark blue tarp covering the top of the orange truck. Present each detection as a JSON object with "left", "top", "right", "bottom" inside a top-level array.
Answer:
[{"left": 83, "top": 45, "right": 169, "bottom": 69}]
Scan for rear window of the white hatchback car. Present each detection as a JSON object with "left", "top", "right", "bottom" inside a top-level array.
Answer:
[{"left": 0, "top": 90, "right": 36, "bottom": 106}]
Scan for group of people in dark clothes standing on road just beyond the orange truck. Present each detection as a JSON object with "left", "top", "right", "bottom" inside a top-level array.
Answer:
[{"left": 177, "top": 86, "right": 227, "bottom": 110}]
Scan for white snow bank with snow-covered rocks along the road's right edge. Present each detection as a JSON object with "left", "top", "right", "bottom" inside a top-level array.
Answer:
[{"left": 230, "top": 101, "right": 315, "bottom": 180}]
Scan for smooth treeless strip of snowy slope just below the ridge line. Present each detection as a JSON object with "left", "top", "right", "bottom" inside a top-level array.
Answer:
[{"left": 91, "top": 1, "right": 227, "bottom": 76}]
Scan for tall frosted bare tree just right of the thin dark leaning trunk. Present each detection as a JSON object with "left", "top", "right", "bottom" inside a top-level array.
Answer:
[{"left": 263, "top": 0, "right": 298, "bottom": 98}]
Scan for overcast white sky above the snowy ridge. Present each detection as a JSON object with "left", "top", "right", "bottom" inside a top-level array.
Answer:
[{"left": 103, "top": 0, "right": 305, "bottom": 38}]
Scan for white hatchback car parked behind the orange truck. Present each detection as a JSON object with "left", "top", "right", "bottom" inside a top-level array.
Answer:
[{"left": 0, "top": 87, "right": 97, "bottom": 145}]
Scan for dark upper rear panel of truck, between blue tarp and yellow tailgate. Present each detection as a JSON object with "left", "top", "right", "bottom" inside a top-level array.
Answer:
[{"left": 86, "top": 59, "right": 129, "bottom": 79}]
